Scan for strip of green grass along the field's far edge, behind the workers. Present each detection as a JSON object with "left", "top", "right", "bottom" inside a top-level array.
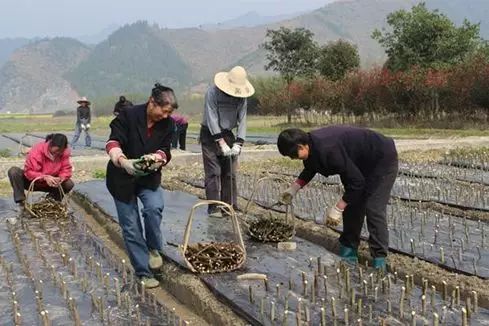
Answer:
[{"left": 0, "top": 114, "right": 489, "bottom": 139}]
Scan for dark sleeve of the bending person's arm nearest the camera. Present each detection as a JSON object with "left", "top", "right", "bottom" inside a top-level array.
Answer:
[{"left": 327, "top": 146, "right": 365, "bottom": 205}]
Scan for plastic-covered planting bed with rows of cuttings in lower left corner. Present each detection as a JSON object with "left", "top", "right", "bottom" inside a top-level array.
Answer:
[{"left": 0, "top": 199, "right": 183, "bottom": 325}]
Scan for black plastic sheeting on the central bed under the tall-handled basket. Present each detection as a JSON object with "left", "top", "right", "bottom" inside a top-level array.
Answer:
[{"left": 76, "top": 181, "right": 489, "bottom": 325}]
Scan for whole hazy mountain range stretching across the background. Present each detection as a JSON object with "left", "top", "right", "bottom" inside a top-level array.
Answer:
[{"left": 0, "top": 0, "right": 489, "bottom": 112}]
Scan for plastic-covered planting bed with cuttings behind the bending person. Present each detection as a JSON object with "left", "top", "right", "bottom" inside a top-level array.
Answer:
[{"left": 177, "top": 164, "right": 489, "bottom": 279}]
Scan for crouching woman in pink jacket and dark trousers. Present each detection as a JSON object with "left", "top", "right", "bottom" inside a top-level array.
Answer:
[{"left": 8, "top": 134, "right": 74, "bottom": 206}]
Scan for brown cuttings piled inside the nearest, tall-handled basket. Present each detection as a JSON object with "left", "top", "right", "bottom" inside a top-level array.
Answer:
[{"left": 185, "top": 242, "right": 245, "bottom": 274}]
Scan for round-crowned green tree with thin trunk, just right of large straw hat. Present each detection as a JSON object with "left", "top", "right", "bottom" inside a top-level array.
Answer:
[{"left": 262, "top": 27, "right": 318, "bottom": 123}]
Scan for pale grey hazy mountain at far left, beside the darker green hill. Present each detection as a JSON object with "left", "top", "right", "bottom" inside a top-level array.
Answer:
[{"left": 0, "top": 38, "right": 89, "bottom": 113}]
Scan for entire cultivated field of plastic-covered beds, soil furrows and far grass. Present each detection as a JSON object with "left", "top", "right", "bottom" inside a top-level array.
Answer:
[{"left": 0, "top": 116, "right": 489, "bottom": 325}]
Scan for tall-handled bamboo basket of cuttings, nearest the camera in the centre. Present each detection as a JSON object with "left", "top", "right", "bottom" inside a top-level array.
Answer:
[{"left": 180, "top": 200, "right": 246, "bottom": 274}]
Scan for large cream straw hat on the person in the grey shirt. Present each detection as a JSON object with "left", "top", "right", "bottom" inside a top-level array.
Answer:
[{"left": 214, "top": 66, "right": 255, "bottom": 98}]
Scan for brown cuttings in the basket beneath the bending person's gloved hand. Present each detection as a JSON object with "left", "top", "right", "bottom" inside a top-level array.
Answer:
[{"left": 248, "top": 217, "right": 295, "bottom": 242}]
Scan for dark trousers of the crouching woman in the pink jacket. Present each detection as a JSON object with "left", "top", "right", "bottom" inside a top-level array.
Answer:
[{"left": 7, "top": 166, "right": 75, "bottom": 203}]
